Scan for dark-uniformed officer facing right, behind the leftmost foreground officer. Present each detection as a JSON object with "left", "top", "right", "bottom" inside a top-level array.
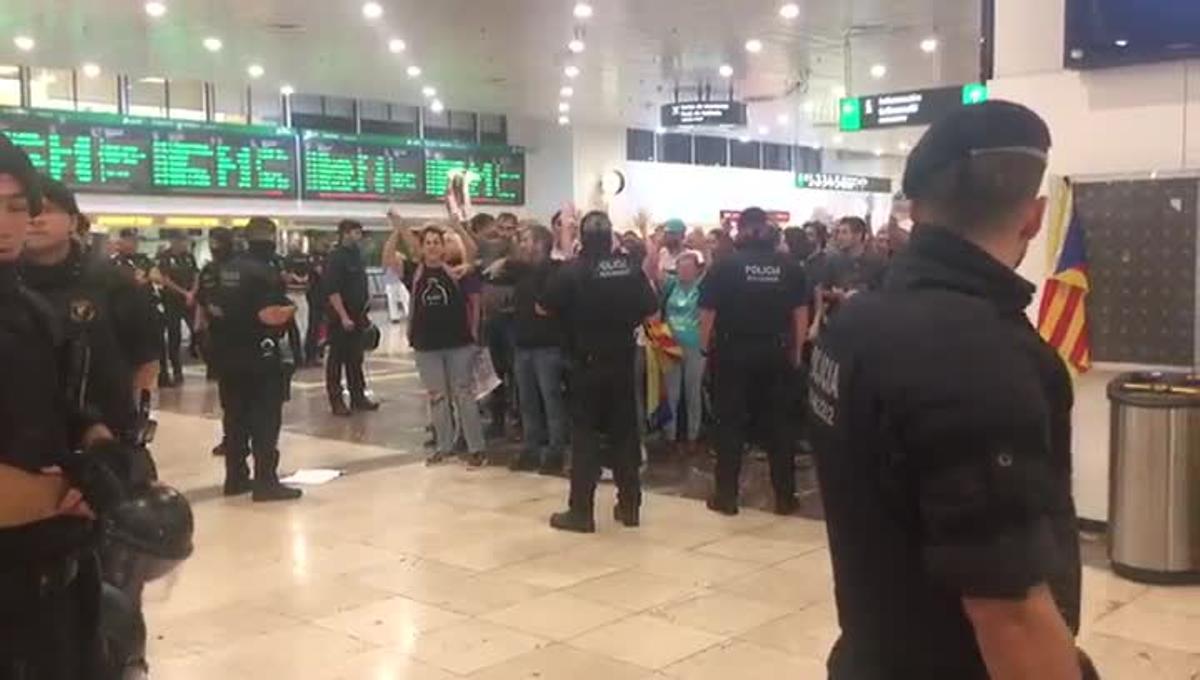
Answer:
[{"left": 20, "top": 177, "right": 160, "bottom": 445}]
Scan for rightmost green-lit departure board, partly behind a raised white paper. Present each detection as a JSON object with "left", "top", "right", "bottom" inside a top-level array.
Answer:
[{"left": 425, "top": 149, "right": 526, "bottom": 205}]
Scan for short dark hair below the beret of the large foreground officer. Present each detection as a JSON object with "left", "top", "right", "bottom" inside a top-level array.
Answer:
[{"left": 912, "top": 151, "right": 1046, "bottom": 233}]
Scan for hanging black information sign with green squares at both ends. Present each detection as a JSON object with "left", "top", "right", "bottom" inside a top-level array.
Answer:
[{"left": 839, "top": 83, "right": 988, "bottom": 132}]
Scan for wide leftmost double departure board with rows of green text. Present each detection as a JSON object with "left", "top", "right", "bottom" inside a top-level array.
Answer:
[{"left": 0, "top": 108, "right": 298, "bottom": 198}]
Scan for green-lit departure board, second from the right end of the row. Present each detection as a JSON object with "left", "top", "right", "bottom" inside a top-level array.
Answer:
[{"left": 301, "top": 131, "right": 425, "bottom": 203}]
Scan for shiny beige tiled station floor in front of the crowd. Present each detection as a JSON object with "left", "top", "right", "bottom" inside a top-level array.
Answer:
[{"left": 146, "top": 321, "right": 1200, "bottom": 680}]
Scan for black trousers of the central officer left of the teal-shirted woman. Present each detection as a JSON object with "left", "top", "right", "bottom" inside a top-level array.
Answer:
[{"left": 570, "top": 347, "right": 642, "bottom": 516}]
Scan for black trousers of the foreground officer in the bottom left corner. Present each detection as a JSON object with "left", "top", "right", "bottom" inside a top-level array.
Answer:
[{"left": 0, "top": 552, "right": 107, "bottom": 680}]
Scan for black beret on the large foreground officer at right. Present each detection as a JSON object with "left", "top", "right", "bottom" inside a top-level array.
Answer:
[{"left": 904, "top": 100, "right": 1050, "bottom": 199}]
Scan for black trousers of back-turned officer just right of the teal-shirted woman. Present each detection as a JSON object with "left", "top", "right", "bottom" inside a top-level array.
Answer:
[{"left": 714, "top": 339, "right": 796, "bottom": 504}]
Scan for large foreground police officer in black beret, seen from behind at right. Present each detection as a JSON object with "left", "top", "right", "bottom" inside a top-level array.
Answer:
[{"left": 810, "top": 101, "right": 1094, "bottom": 680}]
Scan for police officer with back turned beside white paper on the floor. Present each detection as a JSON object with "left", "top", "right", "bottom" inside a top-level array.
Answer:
[{"left": 200, "top": 217, "right": 301, "bottom": 501}]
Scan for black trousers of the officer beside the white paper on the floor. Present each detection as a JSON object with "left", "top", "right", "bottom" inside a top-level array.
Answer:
[{"left": 218, "top": 359, "right": 286, "bottom": 487}]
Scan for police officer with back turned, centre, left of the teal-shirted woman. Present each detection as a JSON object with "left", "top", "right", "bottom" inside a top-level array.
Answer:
[{"left": 542, "top": 211, "right": 658, "bottom": 534}]
